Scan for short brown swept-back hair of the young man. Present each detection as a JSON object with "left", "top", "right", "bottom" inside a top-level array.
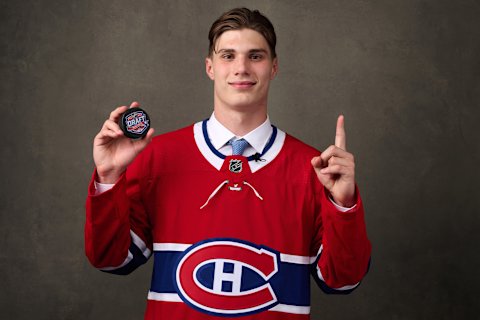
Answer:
[{"left": 208, "top": 8, "right": 277, "bottom": 59}]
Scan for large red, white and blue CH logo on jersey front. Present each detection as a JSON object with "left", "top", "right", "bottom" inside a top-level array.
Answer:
[{"left": 175, "top": 239, "right": 278, "bottom": 317}]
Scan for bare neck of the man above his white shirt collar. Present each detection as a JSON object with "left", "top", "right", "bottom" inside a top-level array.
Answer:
[{"left": 214, "top": 108, "right": 267, "bottom": 137}]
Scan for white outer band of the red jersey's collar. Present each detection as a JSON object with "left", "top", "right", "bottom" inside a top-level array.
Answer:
[{"left": 193, "top": 121, "right": 286, "bottom": 173}]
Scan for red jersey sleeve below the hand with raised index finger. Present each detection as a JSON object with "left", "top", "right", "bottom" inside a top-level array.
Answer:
[{"left": 312, "top": 171, "right": 371, "bottom": 294}]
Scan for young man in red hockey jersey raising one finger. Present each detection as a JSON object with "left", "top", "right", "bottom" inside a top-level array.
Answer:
[{"left": 85, "top": 8, "right": 370, "bottom": 319}]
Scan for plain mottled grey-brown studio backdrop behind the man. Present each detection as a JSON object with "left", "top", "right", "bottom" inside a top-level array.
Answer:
[{"left": 0, "top": 0, "right": 480, "bottom": 320}]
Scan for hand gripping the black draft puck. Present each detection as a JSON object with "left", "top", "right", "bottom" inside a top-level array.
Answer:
[{"left": 93, "top": 102, "right": 154, "bottom": 183}]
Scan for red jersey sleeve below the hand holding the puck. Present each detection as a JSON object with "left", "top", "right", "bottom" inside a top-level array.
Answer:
[{"left": 85, "top": 152, "right": 152, "bottom": 275}]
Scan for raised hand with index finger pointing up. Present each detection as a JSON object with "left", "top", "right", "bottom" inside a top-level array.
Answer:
[{"left": 312, "top": 115, "right": 355, "bottom": 208}]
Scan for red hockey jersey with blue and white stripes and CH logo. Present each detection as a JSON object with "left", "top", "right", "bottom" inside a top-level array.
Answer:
[{"left": 85, "top": 121, "right": 371, "bottom": 320}]
